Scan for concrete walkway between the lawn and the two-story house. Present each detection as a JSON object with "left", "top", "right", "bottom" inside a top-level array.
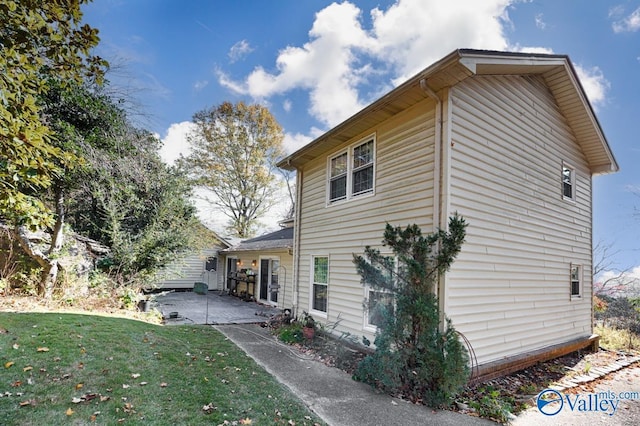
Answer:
[{"left": 216, "top": 324, "right": 495, "bottom": 426}]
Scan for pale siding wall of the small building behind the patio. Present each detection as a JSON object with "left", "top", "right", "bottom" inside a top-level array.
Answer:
[{"left": 158, "top": 249, "right": 224, "bottom": 290}]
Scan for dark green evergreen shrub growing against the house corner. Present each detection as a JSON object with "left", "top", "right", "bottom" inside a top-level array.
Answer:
[{"left": 354, "top": 215, "right": 469, "bottom": 407}]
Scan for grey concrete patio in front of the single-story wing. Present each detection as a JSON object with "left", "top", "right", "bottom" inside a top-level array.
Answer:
[{"left": 151, "top": 291, "right": 280, "bottom": 325}]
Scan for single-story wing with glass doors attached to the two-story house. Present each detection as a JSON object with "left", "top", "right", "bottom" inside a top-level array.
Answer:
[{"left": 221, "top": 219, "right": 293, "bottom": 309}]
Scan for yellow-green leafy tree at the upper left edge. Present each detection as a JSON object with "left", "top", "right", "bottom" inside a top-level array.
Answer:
[{"left": 0, "top": 0, "right": 107, "bottom": 228}]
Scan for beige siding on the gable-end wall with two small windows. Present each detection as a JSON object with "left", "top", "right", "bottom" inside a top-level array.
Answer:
[{"left": 444, "top": 76, "right": 591, "bottom": 363}]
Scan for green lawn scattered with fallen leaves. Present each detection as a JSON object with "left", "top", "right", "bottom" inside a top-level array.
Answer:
[{"left": 0, "top": 312, "right": 322, "bottom": 425}]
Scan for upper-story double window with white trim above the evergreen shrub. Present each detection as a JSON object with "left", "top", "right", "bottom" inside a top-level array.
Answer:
[{"left": 328, "top": 136, "right": 375, "bottom": 203}]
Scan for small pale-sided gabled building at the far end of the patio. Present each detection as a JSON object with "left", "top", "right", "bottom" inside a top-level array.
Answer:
[{"left": 157, "top": 225, "right": 231, "bottom": 290}]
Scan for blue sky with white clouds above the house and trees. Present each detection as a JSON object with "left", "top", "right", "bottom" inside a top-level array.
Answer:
[{"left": 83, "top": 0, "right": 640, "bottom": 279}]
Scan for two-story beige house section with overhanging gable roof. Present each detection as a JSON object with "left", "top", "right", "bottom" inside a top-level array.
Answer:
[{"left": 278, "top": 49, "right": 618, "bottom": 378}]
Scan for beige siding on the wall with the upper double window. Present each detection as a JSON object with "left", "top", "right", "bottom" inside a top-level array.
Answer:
[{"left": 297, "top": 100, "right": 435, "bottom": 337}]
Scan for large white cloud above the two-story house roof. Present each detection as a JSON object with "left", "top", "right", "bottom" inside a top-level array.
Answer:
[{"left": 218, "top": 0, "right": 513, "bottom": 127}]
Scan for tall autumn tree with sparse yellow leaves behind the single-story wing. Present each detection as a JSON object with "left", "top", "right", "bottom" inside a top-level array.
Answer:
[{"left": 180, "top": 102, "right": 284, "bottom": 238}]
